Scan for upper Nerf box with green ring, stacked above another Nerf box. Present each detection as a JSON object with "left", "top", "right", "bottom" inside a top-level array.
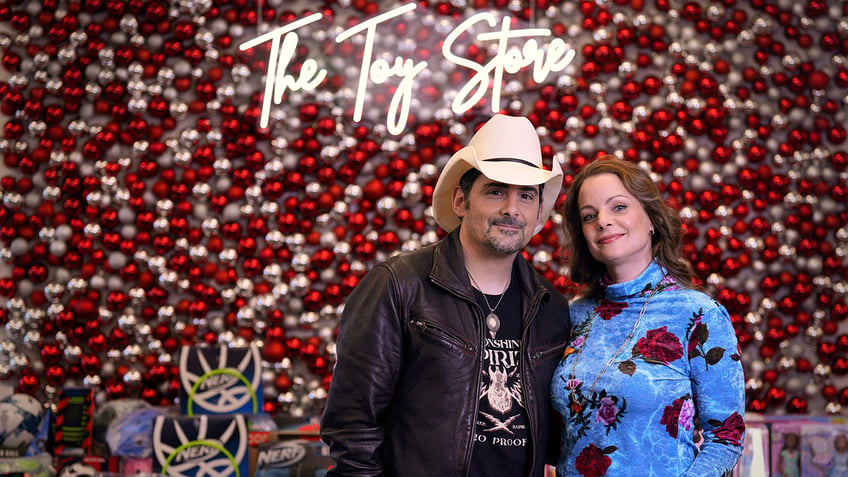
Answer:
[{"left": 179, "top": 345, "right": 262, "bottom": 416}]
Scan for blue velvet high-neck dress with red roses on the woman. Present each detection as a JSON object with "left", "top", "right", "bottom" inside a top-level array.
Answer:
[{"left": 551, "top": 262, "right": 745, "bottom": 477}]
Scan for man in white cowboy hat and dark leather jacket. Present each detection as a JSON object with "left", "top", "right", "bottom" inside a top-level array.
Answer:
[{"left": 321, "top": 114, "right": 570, "bottom": 477}]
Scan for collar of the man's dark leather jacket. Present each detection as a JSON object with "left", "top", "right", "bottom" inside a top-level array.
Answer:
[{"left": 430, "top": 227, "right": 543, "bottom": 298}]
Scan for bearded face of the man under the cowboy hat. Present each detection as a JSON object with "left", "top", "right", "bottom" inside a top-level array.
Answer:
[{"left": 453, "top": 175, "right": 541, "bottom": 254}]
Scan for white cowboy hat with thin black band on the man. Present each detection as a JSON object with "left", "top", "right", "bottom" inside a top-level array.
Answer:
[{"left": 433, "top": 114, "right": 562, "bottom": 235}]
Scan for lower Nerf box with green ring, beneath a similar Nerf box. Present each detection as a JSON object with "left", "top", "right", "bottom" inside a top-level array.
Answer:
[{"left": 152, "top": 414, "right": 249, "bottom": 477}]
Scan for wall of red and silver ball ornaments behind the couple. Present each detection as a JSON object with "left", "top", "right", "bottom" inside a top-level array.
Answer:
[{"left": 0, "top": 0, "right": 848, "bottom": 416}]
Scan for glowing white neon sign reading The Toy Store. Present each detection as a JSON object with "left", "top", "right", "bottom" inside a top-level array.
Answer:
[{"left": 239, "top": 3, "right": 576, "bottom": 135}]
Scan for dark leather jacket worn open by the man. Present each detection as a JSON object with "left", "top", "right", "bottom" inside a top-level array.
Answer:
[{"left": 321, "top": 231, "right": 571, "bottom": 477}]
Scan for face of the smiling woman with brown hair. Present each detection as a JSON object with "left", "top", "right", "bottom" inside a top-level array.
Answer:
[{"left": 577, "top": 173, "right": 653, "bottom": 282}]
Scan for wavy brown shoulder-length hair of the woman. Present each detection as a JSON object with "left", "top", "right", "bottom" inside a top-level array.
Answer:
[{"left": 562, "top": 155, "right": 698, "bottom": 296}]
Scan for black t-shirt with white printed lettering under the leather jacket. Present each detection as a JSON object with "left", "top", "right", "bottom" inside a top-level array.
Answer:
[{"left": 470, "top": 277, "right": 530, "bottom": 477}]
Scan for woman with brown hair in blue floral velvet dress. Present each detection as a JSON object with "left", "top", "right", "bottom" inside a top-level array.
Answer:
[{"left": 551, "top": 156, "right": 745, "bottom": 477}]
